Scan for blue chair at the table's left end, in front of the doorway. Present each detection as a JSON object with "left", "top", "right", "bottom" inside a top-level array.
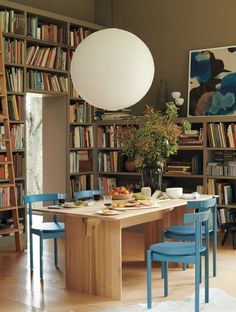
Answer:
[{"left": 24, "top": 194, "right": 64, "bottom": 279}]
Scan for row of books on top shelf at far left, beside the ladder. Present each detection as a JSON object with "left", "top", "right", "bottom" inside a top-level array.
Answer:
[{"left": 0, "top": 10, "right": 25, "bottom": 35}]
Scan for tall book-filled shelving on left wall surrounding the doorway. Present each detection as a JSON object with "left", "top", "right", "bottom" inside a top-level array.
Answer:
[{"left": 0, "top": 0, "right": 103, "bottom": 248}]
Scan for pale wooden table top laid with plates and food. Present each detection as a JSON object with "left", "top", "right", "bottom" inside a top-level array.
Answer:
[{"left": 33, "top": 195, "right": 212, "bottom": 221}]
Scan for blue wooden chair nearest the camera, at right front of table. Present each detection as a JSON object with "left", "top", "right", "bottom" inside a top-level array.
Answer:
[{"left": 147, "top": 210, "right": 210, "bottom": 312}]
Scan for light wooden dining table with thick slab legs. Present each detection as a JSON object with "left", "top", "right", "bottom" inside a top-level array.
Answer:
[{"left": 34, "top": 195, "right": 209, "bottom": 299}]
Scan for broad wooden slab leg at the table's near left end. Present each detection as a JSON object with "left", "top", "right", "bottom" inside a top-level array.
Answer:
[{"left": 65, "top": 216, "right": 122, "bottom": 299}]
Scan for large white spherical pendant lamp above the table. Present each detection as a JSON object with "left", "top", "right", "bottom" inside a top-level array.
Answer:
[{"left": 70, "top": 28, "right": 155, "bottom": 110}]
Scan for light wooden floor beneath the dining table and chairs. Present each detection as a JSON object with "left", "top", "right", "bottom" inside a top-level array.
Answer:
[{"left": 0, "top": 228, "right": 236, "bottom": 312}]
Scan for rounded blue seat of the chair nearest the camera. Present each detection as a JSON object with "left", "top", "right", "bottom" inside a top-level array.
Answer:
[{"left": 150, "top": 242, "right": 206, "bottom": 256}]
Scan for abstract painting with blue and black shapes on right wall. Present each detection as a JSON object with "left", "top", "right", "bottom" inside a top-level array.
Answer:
[{"left": 188, "top": 46, "right": 236, "bottom": 116}]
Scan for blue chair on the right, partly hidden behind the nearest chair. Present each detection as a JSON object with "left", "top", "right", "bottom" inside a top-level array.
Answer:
[{"left": 162, "top": 197, "right": 217, "bottom": 276}]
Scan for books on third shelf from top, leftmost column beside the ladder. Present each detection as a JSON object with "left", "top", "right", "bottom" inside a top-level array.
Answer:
[{"left": 6, "top": 67, "right": 24, "bottom": 92}]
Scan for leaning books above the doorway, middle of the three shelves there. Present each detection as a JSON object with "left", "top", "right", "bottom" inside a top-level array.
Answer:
[{"left": 26, "top": 46, "right": 67, "bottom": 70}]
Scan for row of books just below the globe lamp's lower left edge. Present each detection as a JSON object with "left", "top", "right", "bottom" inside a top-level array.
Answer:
[{"left": 69, "top": 101, "right": 93, "bottom": 123}]
